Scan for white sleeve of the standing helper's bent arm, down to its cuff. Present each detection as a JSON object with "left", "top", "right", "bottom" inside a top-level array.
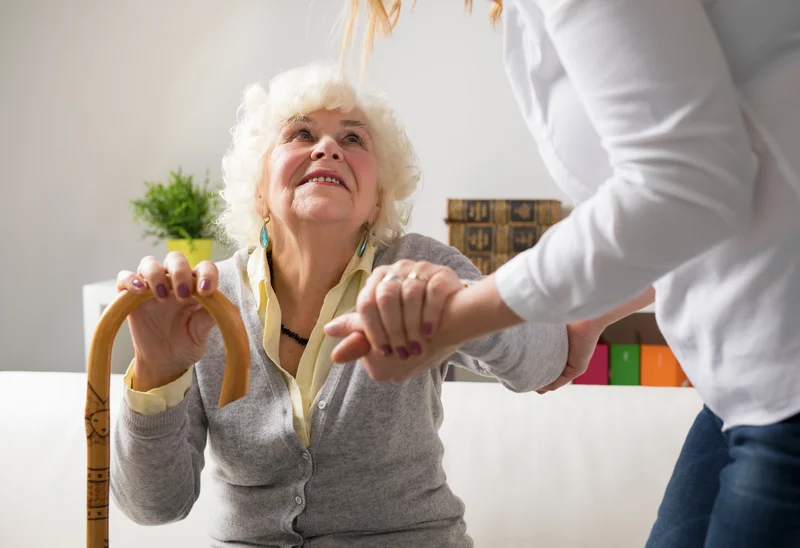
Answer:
[{"left": 496, "top": 0, "right": 757, "bottom": 322}]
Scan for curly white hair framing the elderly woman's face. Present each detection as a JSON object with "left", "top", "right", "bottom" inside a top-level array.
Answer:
[{"left": 217, "top": 63, "right": 419, "bottom": 247}]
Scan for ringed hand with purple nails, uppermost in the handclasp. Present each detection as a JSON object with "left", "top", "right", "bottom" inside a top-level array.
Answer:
[{"left": 348, "top": 260, "right": 464, "bottom": 361}]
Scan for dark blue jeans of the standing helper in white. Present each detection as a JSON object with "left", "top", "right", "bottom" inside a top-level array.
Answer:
[{"left": 646, "top": 407, "right": 800, "bottom": 548}]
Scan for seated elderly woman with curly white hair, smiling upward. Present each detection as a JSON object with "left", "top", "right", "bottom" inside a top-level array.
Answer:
[{"left": 111, "top": 66, "right": 598, "bottom": 548}]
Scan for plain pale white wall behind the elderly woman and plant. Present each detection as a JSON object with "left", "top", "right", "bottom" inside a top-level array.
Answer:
[{"left": 0, "top": 0, "right": 566, "bottom": 371}]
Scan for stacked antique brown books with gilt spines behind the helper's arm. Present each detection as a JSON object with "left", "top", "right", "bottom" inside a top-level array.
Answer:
[{"left": 445, "top": 198, "right": 561, "bottom": 275}]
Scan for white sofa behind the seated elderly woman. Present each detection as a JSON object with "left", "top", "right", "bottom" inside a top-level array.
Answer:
[{"left": 0, "top": 371, "right": 701, "bottom": 548}]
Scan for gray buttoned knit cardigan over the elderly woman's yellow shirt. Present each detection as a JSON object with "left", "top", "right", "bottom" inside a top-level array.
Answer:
[{"left": 111, "top": 234, "right": 567, "bottom": 548}]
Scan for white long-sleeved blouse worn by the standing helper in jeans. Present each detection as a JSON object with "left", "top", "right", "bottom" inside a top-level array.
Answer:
[{"left": 496, "top": 0, "right": 800, "bottom": 428}]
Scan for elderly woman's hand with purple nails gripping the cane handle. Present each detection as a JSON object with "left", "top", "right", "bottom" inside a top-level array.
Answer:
[{"left": 117, "top": 252, "right": 219, "bottom": 392}]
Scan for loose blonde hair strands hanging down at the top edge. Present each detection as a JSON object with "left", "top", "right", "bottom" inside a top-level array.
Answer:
[{"left": 341, "top": 0, "right": 503, "bottom": 72}]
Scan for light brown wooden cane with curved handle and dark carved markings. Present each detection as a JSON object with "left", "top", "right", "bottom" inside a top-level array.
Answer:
[{"left": 85, "top": 280, "right": 250, "bottom": 548}]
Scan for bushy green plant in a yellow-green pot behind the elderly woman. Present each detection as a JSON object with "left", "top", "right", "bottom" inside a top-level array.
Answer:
[{"left": 131, "top": 168, "right": 219, "bottom": 268}]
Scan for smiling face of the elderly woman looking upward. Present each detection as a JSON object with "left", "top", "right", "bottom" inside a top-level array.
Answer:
[{"left": 258, "top": 109, "right": 378, "bottom": 233}]
